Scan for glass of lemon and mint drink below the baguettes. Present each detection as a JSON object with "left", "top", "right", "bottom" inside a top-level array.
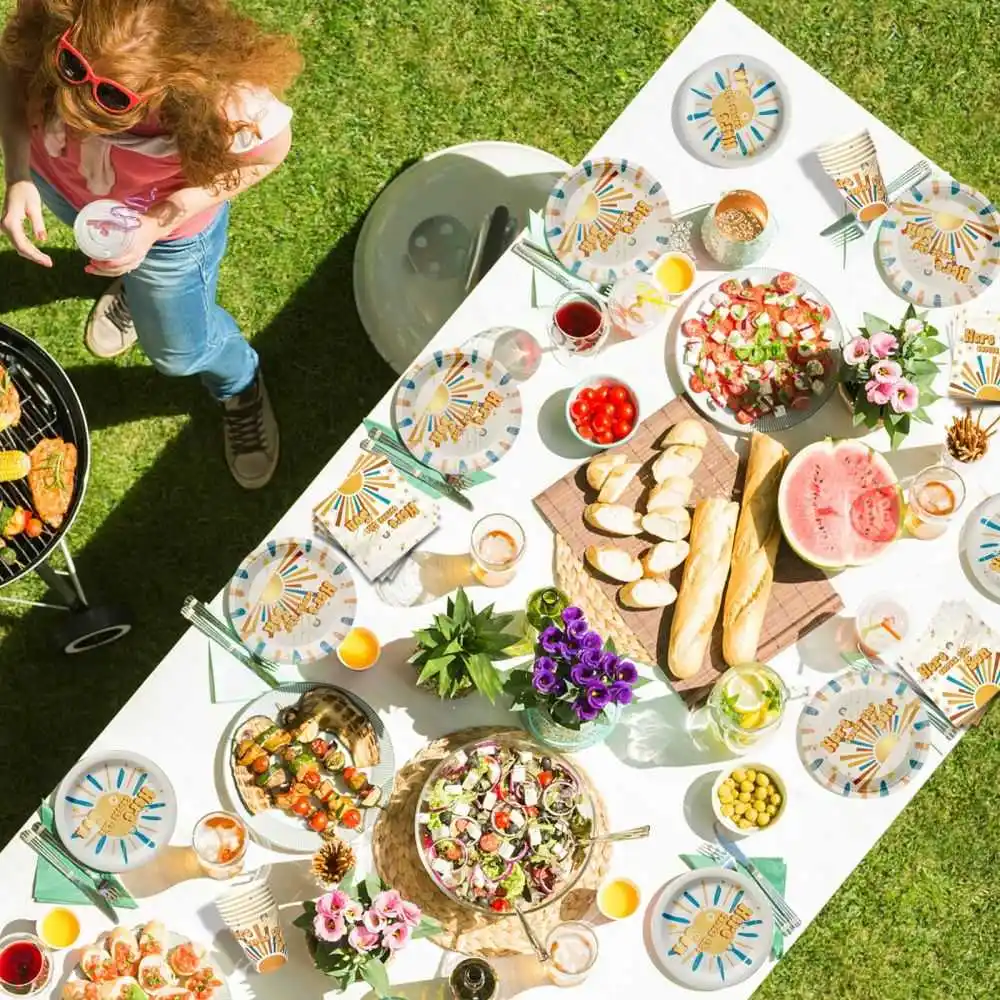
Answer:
[{"left": 708, "top": 663, "right": 788, "bottom": 753}]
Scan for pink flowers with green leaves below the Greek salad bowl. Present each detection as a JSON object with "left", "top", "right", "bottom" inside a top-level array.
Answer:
[{"left": 294, "top": 870, "right": 441, "bottom": 997}]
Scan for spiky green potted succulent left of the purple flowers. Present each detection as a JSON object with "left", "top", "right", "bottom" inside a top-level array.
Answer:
[{"left": 409, "top": 587, "right": 520, "bottom": 702}]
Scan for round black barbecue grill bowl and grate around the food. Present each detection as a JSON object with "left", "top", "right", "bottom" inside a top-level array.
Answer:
[{"left": 0, "top": 323, "right": 90, "bottom": 587}]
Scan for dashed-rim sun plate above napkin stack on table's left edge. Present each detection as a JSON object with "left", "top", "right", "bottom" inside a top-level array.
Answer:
[{"left": 393, "top": 349, "right": 521, "bottom": 476}]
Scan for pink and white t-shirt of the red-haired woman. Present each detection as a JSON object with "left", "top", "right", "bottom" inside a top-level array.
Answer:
[{"left": 31, "top": 87, "right": 292, "bottom": 239}]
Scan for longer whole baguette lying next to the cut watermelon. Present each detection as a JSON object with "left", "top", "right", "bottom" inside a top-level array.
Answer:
[{"left": 722, "top": 434, "right": 788, "bottom": 667}]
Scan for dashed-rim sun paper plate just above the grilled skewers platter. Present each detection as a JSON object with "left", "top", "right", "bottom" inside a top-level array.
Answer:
[{"left": 225, "top": 538, "right": 358, "bottom": 663}]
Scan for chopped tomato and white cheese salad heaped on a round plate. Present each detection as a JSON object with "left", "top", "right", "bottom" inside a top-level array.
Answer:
[{"left": 681, "top": 271, "right": 837, "bottom": 424}]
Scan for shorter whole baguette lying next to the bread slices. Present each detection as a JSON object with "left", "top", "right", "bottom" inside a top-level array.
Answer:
[{"left": 667, "top": 497, "right": 740, "bottom": 680}]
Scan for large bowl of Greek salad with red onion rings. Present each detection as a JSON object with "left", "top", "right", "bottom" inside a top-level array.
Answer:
[{"left": 415, "top": 737, "right": 594, "bottom": 916}]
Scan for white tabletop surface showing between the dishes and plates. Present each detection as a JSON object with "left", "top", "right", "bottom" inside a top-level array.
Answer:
[{"left": 0, "top": 0, "right": 1000, "bottom": 1000}]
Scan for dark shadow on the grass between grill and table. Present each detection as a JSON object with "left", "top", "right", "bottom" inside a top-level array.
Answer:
[{"left": 0, "top": 213, "right": 394, "bottom": 844}]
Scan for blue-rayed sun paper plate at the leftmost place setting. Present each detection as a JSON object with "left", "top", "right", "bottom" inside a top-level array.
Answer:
[{"left": 53, "top": 750, "right": 177, "bottom": 872}]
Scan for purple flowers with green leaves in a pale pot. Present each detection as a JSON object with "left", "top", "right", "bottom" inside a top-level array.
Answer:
[{"left": 504, "top": 605, "right": 639, "bottom": 729}]
